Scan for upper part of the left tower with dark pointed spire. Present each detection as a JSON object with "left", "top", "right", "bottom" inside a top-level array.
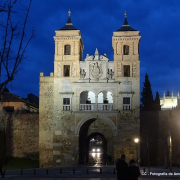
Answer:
[{"left": 54, "top": 10, "right": 84, "bottom": 78}]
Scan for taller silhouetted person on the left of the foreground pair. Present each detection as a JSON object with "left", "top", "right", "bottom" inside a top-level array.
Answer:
[{"left": 116, "top": 154, "right": 128, "bottom": 180}]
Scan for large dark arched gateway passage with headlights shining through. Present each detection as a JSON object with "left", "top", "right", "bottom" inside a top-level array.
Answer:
[{"left": 78, "top": 118, "right": 114, "bottom": 164}]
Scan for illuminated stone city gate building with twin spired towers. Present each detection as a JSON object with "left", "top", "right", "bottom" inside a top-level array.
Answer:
[{"left": 39, "top": 11, "right": 140, "bottom": 167}]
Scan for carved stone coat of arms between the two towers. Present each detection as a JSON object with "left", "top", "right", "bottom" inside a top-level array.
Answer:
[{"left": 90, "top": 62, "right": 103, "bottom": 80}]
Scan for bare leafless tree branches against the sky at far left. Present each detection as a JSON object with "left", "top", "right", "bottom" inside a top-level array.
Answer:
[{"left": 0, "top": 0, "right": 34, "bottom": 98}]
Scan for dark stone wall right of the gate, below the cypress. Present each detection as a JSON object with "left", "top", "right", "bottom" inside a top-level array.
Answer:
[{"left": 140, "top": 109, "right": 180, "bottom": 167}]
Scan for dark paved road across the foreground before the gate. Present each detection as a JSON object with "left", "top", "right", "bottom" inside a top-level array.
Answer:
[{"left": 1, "top": 166, "right": 180, "bottom": 180}]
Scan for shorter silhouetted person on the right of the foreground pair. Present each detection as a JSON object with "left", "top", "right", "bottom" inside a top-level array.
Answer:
[{"left": 128, "top": 159, "right": 140, "bottom": 180}]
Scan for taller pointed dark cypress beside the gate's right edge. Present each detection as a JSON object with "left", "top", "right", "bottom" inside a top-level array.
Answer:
[{"left": 141, "top": 73, "right": 154, "bottom": 111}]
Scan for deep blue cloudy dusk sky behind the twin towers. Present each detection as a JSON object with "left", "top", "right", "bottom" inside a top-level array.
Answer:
[{"left": 1, "top": 0, "right": 180, "bottom": 97}]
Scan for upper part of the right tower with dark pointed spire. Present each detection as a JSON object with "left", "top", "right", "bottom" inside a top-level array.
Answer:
[{"left": 112, "top": 12, "right": 141, "bottom": 78}]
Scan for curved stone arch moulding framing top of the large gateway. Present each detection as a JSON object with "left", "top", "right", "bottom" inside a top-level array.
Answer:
[{"left": 75, "top": 114, "right": 117, "bottom": 136}]
